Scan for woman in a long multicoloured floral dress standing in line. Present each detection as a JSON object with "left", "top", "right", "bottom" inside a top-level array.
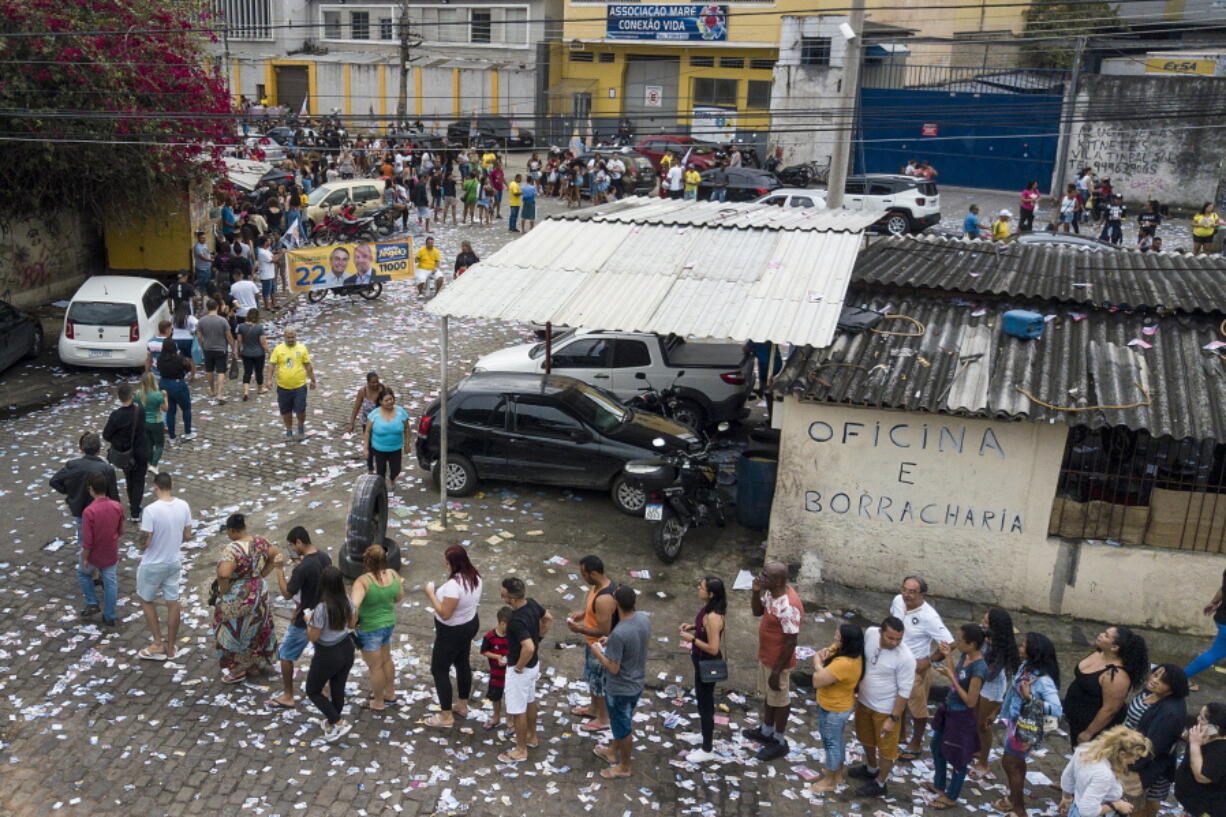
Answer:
[{"left": 213, "top": 514, "right": 277, "bottom": 683}]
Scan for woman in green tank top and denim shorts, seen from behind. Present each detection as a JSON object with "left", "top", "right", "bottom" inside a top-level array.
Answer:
[{"left": 351, "top": 545, "right": 405, "bottom": 712}]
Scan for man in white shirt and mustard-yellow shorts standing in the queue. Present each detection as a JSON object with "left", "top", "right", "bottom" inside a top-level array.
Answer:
[{"left": 847, "top": 616, "right": 916, "bottom": 797}]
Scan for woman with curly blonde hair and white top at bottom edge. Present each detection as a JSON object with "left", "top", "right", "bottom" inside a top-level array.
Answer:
[{"left": 1059, "top": 726, "right": 1152, "bottom": 817}]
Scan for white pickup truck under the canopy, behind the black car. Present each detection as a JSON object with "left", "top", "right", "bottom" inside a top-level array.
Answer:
[{"left": 473, "top": 329, "right": 754, "bottom": 429}]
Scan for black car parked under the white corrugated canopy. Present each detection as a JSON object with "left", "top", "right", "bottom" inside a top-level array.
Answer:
[{"left": 413, "top": 372, "right": 702, "bottom": 515}]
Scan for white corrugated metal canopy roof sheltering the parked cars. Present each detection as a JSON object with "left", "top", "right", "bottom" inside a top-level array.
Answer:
[{"left": 427, "top": 199, "right": 875, "bottom": 346}]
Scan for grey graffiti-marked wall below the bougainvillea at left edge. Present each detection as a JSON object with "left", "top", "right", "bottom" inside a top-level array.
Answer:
[{"left": 0, "top": 211, "right": 105, "bottom": 307}]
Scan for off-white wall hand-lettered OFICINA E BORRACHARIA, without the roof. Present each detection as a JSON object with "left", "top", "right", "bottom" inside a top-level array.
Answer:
[{"left": 767, "top": 397, "right": 1221, "bottom": 632}]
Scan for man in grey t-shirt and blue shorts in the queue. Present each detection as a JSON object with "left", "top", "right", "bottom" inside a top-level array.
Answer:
[{"left": 591, "top": 584, "right": 651, "bottom": 779}]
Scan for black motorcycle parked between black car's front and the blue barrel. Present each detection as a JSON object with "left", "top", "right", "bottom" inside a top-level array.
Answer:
[{"left": 624, "top": 423, "right": 728, "bottom": 564}]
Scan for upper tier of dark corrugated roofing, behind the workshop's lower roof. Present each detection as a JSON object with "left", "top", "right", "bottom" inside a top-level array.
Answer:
[{"left": 855, "top": 236, "right": 1226, "bottom": 313}]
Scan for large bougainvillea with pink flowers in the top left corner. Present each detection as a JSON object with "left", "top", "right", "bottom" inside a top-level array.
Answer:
[{"left": 0, "top": 0, "right": 234, "bottom": 215}]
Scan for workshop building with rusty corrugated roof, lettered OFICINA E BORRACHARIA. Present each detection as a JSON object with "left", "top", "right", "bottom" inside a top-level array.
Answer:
[{"left": 769, "top": 238, "right": 1226, "bottom": 631}]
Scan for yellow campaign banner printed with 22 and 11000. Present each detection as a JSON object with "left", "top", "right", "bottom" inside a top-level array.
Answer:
[{"left": 286, "top": 238, "right": 413, "bottom": 292}]
